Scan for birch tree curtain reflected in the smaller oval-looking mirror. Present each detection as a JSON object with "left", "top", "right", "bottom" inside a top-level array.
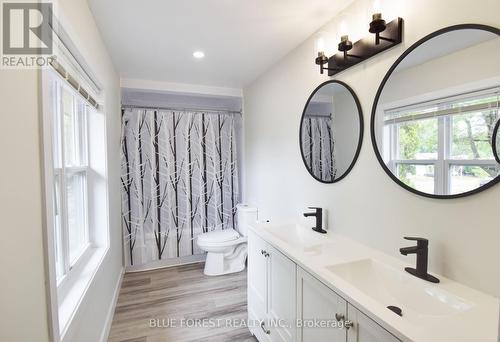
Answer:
[{"left": 302, "top": 116, "right": 337, "bottom": 181}]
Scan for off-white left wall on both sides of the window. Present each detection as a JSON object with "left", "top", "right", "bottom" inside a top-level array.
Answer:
[{"left": 0, "top": 0, "right": 122, "bottom": 342}]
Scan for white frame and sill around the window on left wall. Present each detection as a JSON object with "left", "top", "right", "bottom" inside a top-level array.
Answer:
[{"left": 40, "top": 68, "right": 111, "bottom": 341}]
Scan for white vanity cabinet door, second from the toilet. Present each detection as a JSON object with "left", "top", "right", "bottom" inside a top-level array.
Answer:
[{"left": 267, "top": 246, "right": 297, "bottom": 342}]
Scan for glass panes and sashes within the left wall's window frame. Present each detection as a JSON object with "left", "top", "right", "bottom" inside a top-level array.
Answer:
[{"left": 52, "top": 79, "right": 92, "bottom": 283}]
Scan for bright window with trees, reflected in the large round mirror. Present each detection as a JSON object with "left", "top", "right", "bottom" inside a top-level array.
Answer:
[{"left": 383, "top": 89, "right": 500, "bottom": 195}]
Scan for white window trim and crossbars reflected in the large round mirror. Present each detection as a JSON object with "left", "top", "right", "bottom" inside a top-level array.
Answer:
[{"left": 375, "top": 77, "right": 500, "bottom": 195}]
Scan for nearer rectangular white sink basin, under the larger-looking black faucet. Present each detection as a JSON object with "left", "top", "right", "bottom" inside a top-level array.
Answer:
[{"left": 326, "top": 259, "right": 474, "bottom": 320}]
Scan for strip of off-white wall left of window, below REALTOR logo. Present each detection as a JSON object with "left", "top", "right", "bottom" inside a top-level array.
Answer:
[{"left": 0, "top": 70, "right": 49, "bottom": 342}]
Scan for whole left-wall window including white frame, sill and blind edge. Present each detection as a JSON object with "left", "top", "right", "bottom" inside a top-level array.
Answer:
[{"left": 42, "top": 64, "right": 109, "bottom": 340}]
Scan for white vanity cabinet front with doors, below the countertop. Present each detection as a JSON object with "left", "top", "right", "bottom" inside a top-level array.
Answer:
[{"left": 248, "top": 231, "right": 400, "bottom": 342}]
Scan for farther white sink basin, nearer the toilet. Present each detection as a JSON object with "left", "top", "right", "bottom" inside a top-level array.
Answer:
[{"left": 266, "top": 224, "right": 327, "bottom": 251}]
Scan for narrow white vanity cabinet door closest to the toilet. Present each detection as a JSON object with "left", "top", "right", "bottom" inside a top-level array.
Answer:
[{"left": 247, "top": 231, "right": 269, "bottom": 342}]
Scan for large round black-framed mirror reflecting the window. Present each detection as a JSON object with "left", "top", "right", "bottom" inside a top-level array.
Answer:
[{"left": 370, "top": 24, "right": 500, "bottom": 199}]
